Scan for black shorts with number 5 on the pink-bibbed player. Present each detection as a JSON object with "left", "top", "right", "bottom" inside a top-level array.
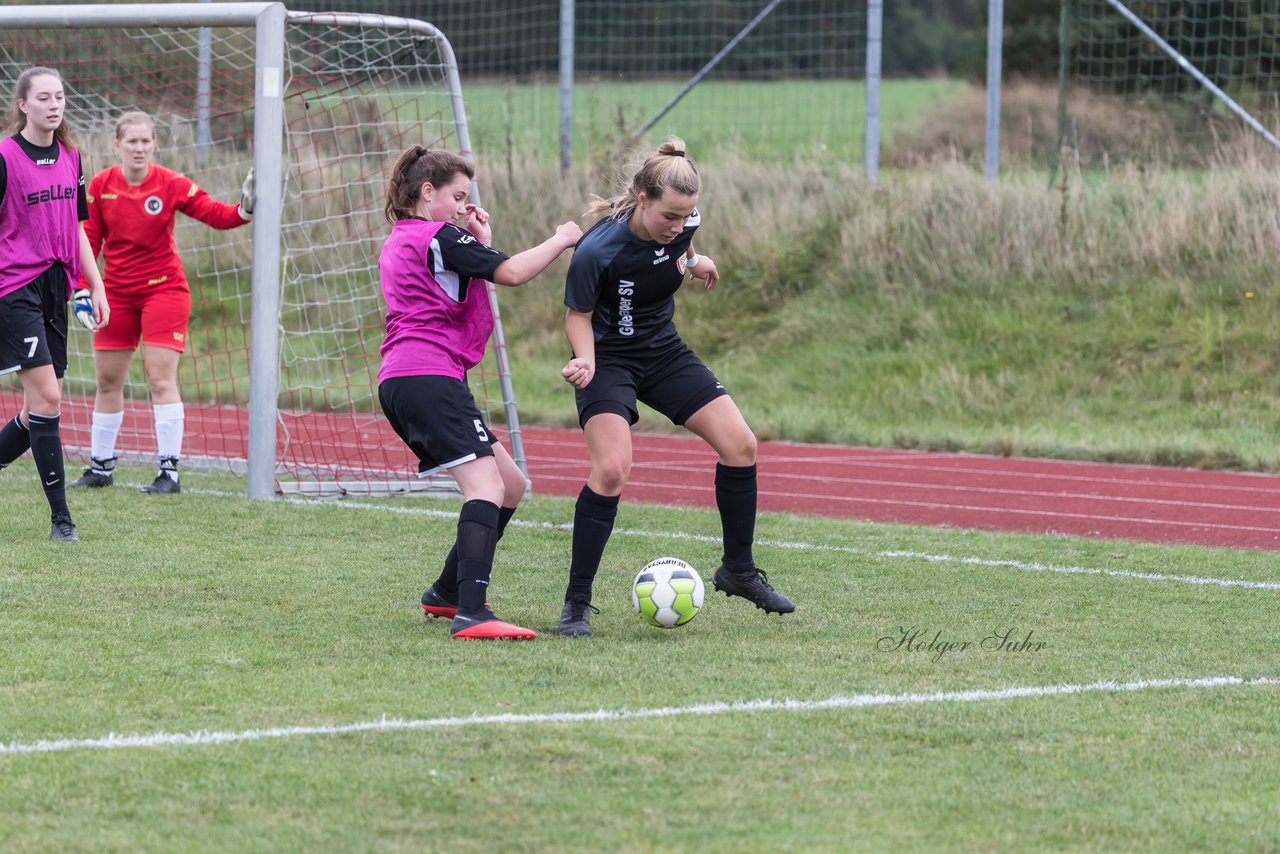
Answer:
[{"left": 378, "top": 376, "right": 498, "bottom": 478}]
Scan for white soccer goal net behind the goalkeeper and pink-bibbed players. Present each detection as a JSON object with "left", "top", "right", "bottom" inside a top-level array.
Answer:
[{"left": 0, "top": 4, "right": 524, "bottom": 494}]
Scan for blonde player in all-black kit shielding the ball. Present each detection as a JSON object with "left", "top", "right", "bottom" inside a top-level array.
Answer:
[{"left": 559, "top": 138, "right": 795, "bottom": 636}]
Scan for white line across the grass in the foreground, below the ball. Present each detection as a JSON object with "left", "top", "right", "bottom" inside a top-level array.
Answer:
[{"left": 0, "top": 676, "right": 1280, "bottom": 755}]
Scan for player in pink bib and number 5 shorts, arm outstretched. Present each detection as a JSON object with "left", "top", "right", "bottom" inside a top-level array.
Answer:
[{"left": 378, "top": 146, "right": 582, "bottom": 640}]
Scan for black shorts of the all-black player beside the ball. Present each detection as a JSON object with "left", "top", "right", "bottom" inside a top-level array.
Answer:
[{"left": 575, "top": 342, "right": 728, "bottom": 426}]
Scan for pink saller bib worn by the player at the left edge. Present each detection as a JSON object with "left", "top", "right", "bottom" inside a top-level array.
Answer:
[{"left": 0, "top": 137, "right": 81, "bottom": 297}]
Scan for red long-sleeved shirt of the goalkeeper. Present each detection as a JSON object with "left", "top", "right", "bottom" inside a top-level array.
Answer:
[{"left": 79, "top": 164, "right": 248, "bottom": 300}]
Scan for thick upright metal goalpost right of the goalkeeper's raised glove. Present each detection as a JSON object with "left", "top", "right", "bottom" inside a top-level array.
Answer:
[{"left": 248, "top": 3, "right": 287, "bottom": 499}]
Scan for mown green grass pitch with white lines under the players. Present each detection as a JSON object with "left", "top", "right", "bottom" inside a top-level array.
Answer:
[{"left": 0, "top": 461, "right": 1280, "bottom": 851}]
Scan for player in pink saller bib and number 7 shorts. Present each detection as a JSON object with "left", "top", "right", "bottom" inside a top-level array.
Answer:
[{"left": 0, "top": 67, "right": 110, "bottom": 543}]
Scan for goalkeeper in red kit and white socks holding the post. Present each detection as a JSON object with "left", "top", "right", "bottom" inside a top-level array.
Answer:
[{"left": 70, "top": 113, "right": 253, "bottom": 494}]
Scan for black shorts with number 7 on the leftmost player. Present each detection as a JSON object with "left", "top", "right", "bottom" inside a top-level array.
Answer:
[{"left": 0, "top": 264, "right": 67, "bottom": 378}]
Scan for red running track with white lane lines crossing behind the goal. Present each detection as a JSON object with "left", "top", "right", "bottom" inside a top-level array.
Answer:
[{"left": 10, "top": 389, "right": 1280, "bottom": 551}]
